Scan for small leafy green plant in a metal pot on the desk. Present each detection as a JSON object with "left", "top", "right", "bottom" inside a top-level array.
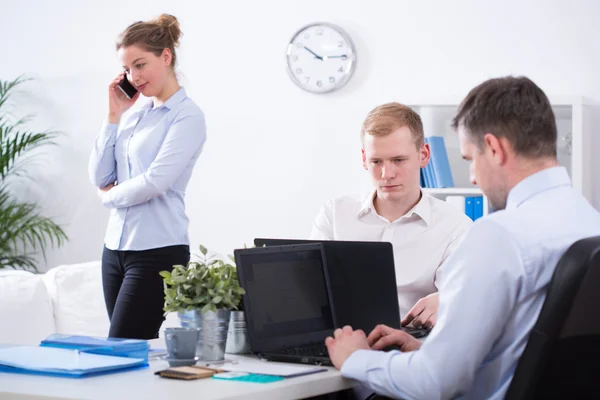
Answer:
[{"left": 160, "top": 245, "right": 244, "bottom": 361}]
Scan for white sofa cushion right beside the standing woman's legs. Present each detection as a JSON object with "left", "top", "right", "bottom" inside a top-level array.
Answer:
[{"left": 43, "top": 261, "right": 109, "bottom": 337}]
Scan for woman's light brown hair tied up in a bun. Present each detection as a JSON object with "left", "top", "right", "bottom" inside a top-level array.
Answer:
[{"left": 117, "top": 14, "right": 182, "bottom": 67}]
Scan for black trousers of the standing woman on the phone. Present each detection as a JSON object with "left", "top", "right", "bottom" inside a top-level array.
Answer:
[{"left": 102, "top": 246, "right": 190, "bottom": 340}]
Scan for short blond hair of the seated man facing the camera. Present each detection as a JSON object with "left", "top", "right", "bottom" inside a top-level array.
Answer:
[{"left": 360, "top": 103, "right": 425, "bottom": 150}]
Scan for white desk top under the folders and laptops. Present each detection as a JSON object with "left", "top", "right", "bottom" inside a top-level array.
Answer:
[{"left": 0, "top": 346, "right": 355, "bottom": 400}]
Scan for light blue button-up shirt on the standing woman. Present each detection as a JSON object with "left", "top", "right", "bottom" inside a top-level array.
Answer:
[{"left": 89, "top": 88, "right": 206, "bottom": 250}]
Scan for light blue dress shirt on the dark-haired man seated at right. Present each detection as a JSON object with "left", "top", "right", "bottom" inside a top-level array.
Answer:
[{"left": 342, "top": 167, "right": 600, "bottom": 400}]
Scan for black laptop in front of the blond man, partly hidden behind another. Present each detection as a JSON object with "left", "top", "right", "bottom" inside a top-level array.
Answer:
[{"left": 254, "top": 238, "right": 430, "bottom": 338}]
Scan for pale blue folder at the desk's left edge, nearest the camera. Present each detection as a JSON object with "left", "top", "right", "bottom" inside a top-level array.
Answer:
[{"left": 0, "top": 346, "right": 148, "bottom": 378}]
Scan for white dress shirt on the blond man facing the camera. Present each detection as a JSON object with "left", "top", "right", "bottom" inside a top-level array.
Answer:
[{"left": 310, "top": 191, "right": 473, "bottom": 317}]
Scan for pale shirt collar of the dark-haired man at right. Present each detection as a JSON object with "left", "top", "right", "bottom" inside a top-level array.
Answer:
[{"left": 506, "top": 167, "right": 571, "bottom": 209}]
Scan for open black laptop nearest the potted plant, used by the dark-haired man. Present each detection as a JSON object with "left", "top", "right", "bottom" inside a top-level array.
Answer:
[{"left": 234, "top": 243, "right": 335, "bottom": 365}]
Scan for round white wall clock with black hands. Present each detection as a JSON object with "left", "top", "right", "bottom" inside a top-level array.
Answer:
[{"left": 287, "top": 23, "right": 356, "bottom": 93}]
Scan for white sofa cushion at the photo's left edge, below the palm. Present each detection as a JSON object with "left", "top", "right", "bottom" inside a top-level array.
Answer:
[{"left": 0, "top": 270, "right": 55, "bottom": 345}]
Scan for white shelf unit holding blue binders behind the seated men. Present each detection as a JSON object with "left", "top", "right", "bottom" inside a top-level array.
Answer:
[{"left": 406, "top": 96, "right": 591, "bottom": 215}]
